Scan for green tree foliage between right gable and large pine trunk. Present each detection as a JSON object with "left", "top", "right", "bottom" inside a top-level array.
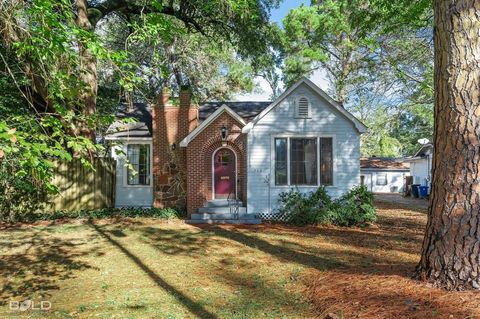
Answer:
[{"left": 280, "top": 0, "right": 433, "bottom": 156}]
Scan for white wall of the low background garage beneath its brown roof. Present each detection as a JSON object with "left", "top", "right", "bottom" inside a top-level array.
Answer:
[{"left": 360, "top": 169, "right": 410, "bottom": 193}]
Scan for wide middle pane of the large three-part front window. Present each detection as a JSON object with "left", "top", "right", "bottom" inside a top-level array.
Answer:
[{"left": 290, "top": 138, "right": 317, "bottom": 185}]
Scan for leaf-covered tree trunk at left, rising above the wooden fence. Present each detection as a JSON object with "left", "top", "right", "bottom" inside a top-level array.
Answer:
[{"left": 77, "top": 0, "right": 97, "bottom": 141}]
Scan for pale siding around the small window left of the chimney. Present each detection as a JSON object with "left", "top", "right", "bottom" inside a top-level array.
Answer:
[{"left": 112, "top": 141, "right": 153, "bottom": 207}]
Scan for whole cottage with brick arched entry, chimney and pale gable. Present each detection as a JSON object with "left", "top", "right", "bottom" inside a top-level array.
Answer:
[{"left": 106, "top": 78, "right": 367, "bottom": 222}]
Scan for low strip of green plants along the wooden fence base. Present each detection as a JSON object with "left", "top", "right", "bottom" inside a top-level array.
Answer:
[{"left": 3, "top": 207, "right": 185, "bottom": 222}]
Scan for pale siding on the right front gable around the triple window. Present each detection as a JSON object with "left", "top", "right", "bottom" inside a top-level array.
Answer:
[{"left": 247, "top": 84, "right": 360, "bottom": 213}]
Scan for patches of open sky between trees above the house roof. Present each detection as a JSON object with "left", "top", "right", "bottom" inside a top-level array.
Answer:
[{"left": 235, "top": 0, "right": 329, "bottom": 101}]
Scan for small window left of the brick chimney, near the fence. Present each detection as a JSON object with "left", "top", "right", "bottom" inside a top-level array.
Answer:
[{"left": 127, "top": 144, "right": 150, "bottom": 185}]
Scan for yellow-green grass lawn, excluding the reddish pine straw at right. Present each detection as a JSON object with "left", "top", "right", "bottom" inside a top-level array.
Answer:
[{"left": 0, "top": 219, "right": 314, "bottom": 318}]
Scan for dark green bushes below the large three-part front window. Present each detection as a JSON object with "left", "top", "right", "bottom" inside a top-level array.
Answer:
[{"left": 279, "top": 186, "right": 377, "bottom": 227}]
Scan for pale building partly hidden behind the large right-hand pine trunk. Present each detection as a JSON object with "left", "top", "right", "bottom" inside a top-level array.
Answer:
[{"left": 403, "top": 144, "right": 433, "bottom": 192}]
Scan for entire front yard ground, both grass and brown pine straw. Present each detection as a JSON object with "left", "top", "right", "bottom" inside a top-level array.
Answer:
[{"left": 0, "top": 203, "right": 480, "bottom": 318}]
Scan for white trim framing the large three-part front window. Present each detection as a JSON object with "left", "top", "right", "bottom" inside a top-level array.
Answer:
[{"left": 270, "top": 133, "right": 337, "bottom": 189}]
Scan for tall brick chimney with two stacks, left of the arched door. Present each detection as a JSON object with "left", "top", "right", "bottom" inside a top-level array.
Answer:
[{"left": 152, "top": 88, "right": 198, "bottom": 209}]
